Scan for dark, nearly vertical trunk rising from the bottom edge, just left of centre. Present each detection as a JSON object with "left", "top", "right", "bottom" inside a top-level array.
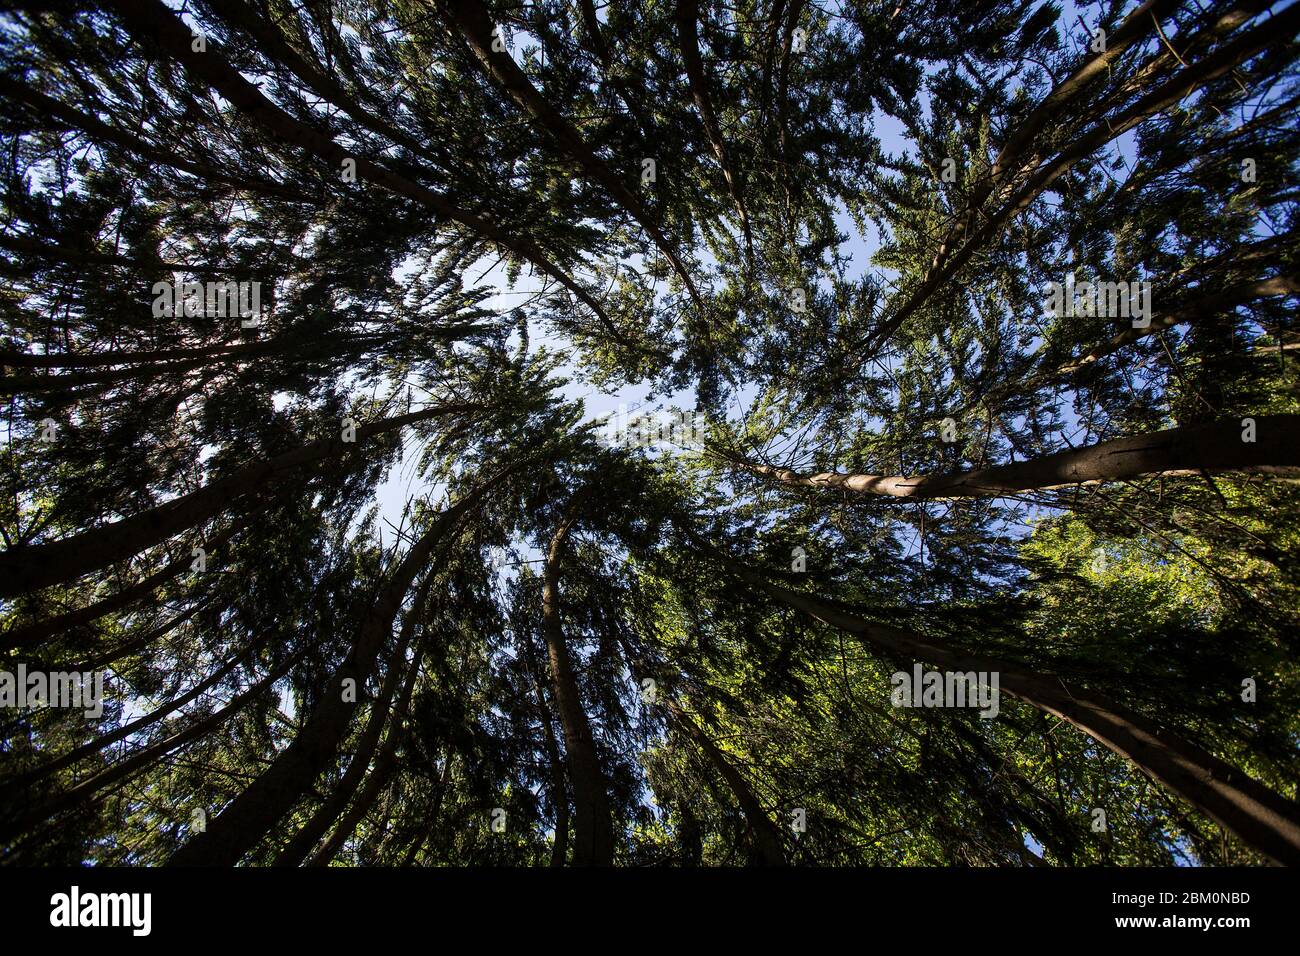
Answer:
[{"left": 542, "top": 502, "right": 614, "bottom": 866}]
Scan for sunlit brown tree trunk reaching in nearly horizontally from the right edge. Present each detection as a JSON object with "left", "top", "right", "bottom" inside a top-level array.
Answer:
[{"left": 728, "top": 415, "right": 1300, "bottom": 499}]
